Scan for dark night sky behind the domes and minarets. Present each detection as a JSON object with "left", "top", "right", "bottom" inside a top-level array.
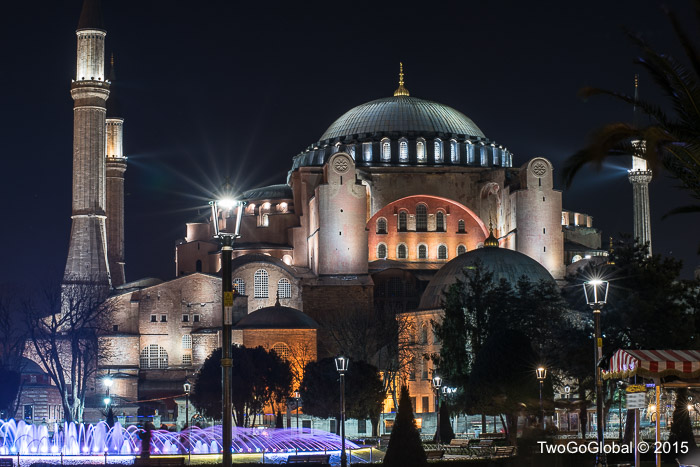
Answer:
[{"left": 0, "top": 0, "right": 700, "bottom": 286}]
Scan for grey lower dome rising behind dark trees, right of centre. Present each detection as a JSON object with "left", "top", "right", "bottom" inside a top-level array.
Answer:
[{"left": 419, "top": 247, "right": 554, "bottom": 310}]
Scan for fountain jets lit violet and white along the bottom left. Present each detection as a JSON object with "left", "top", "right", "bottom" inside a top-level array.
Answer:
[{"left": 0, "top": 420, "right": 358, "bottom": 456}]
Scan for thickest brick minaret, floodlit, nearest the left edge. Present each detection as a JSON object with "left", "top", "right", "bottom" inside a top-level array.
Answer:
[{"left": 63, "top": 0, "right": 110, "bottom": 286}]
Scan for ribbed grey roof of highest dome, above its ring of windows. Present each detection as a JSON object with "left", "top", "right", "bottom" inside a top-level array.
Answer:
[{"left": 319, "top": 96, "right": 485, "bottom": 141}]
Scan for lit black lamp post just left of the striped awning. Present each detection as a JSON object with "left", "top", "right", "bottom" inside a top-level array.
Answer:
[{"left": 583, "top": 279, "right": 609, "bottom": 465}]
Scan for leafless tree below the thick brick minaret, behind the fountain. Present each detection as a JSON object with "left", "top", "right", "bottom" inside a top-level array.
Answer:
[{"left": 27, "top": 281, "right": 113, "bottom": 422}]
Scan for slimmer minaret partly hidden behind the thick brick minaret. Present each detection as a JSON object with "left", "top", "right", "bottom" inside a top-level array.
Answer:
[{"left": 106, "top": 54, "right": 126, "bottom": 287}]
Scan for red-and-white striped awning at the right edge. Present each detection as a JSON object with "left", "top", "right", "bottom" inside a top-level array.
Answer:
[{"left": 603, "top": 349, "right": 700, "bottom": 379}]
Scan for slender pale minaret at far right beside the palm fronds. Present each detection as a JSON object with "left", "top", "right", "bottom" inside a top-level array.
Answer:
[{"left": 628, "top": 75, "right": 652, "bottom": 255}]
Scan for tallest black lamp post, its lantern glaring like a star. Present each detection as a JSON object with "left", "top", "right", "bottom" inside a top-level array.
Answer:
[{"left": 209, "top": 199, "right": 243, "bottom": 467}]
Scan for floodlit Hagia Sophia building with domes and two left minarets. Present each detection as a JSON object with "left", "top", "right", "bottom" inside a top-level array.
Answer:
[{"left": 21, "top": 0, "right": 607, "bottom": 434}]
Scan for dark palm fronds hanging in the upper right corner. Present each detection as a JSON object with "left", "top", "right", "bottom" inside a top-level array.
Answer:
[{"left": 563, "top": 0, "right": 700, "bottom": 223}]
